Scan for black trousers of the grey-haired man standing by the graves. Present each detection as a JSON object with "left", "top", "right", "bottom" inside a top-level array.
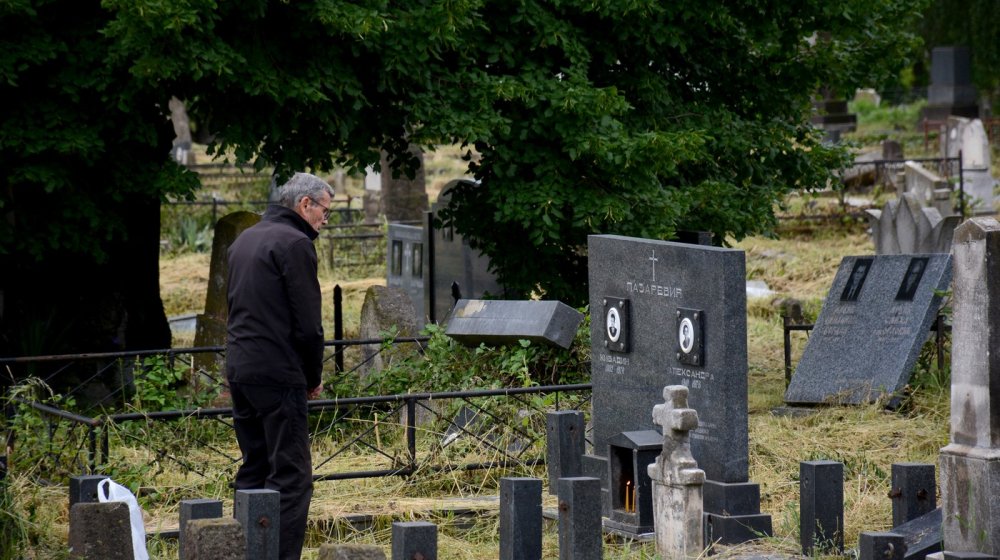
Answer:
[{"left": 229, "top": 382, "right": 312, "bottom": 560}]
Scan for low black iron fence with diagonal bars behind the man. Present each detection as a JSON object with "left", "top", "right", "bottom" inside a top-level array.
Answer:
[{"left": 0, "top": 337, "right": 590, "bottom": 480}]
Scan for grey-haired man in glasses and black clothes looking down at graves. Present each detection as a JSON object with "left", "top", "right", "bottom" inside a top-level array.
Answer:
[{"left": 226, "top": 173, "right": 333, "bottom": 560}]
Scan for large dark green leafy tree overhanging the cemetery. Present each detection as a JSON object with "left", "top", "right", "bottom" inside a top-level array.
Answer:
[{"left": 0, "top": 0, "right": 919, "bottom": 353}]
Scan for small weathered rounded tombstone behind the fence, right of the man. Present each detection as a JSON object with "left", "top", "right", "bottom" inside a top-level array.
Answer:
[{"left": 358, "top": 285, "right": 423, "bottom": 379}]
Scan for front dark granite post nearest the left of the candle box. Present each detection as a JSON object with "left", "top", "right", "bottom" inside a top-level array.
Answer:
[{"left": 559, "top": 477, "right": 604, "bottom": 560}]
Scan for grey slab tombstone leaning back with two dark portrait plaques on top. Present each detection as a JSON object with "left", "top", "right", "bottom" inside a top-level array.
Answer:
[{"left": 785, "top": 254, "right": 951, "bottom": 406}]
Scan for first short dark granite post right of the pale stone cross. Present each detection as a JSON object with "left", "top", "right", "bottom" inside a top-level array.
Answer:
[{"left": 799, "top": 461, "right": 844, "bottom": 556}]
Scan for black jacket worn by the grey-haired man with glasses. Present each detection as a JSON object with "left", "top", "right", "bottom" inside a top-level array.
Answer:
[{"left": 226, "top": 206, "right": 323, "bottom": 389}]
